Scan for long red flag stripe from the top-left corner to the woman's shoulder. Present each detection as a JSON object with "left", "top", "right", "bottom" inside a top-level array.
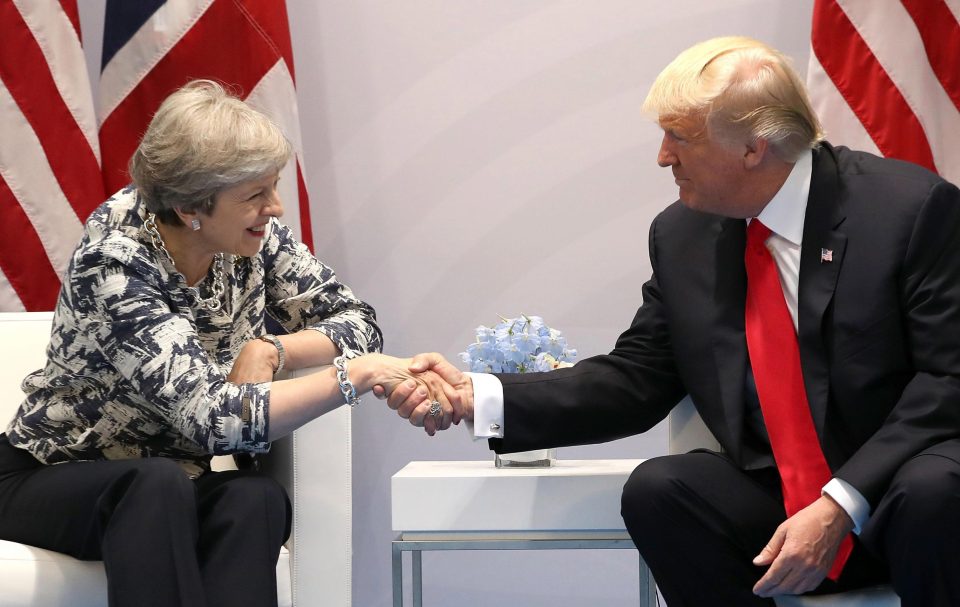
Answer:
[{"left": 0, "top": 2, "right": 103, "bottom": 221}]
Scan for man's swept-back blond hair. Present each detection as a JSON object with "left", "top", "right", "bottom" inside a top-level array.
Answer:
[{"left": 643, "top": 36, "right": 824, "bottom": 162}]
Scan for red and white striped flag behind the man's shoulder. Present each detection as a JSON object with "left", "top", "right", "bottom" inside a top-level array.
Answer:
[{"left": 807, "top": 0, "right": 960, "bottom": 183}]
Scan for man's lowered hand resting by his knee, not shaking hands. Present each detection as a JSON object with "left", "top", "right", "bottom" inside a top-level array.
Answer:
[{"left": 753, "top": 495, "right": 853, "bottom": 597}]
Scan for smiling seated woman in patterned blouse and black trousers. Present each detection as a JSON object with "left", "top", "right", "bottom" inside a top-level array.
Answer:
[{"left": 0, "top": 81, "right": 451, "bottom": 607}]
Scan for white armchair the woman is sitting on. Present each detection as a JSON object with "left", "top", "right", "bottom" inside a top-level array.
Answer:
[{"left": 0, "top": 312, "right": 352, "bottom": 607}]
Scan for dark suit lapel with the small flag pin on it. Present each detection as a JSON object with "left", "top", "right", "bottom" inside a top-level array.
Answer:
[{"left": 798, "top": 144, "right": 847, "bottom": 443}]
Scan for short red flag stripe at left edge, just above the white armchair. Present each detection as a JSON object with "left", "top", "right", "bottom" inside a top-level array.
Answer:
[{"left": 0, "top": 177, "right": 60, "bottom": 312}]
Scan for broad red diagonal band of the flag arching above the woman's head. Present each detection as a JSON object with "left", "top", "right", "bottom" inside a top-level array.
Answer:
[{"left": 100, "top": 2, "right": 290, "bottom": 192}]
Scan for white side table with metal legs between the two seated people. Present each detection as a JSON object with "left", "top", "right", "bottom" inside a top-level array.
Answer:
[{"left": 391, "top": 460, "right": 656, "bottom": 607}]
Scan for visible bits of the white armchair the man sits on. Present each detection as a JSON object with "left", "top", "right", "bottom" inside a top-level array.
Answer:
[{"left": 669, "top": 397, "right": 900, "bottom": 607}]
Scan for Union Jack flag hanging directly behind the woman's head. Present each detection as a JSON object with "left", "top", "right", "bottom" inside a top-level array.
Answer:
[{"left": 99, "top": 0, "right": 313, "bottom": 250}]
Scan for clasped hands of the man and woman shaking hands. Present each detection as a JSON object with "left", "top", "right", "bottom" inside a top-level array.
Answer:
[{"left": 361, "top": 352, "right": 473, "bottom": 436}]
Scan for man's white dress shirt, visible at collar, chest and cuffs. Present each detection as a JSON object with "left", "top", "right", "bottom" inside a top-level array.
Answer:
[{"left": 467, "top": 152, "right": 870, "bottom": 533}]
